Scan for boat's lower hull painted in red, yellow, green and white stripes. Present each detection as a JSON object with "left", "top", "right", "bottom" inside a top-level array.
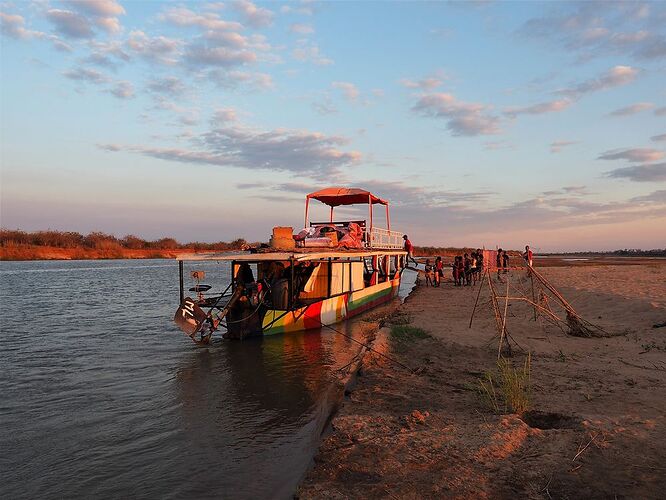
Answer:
[{"left": 262, "top": 277, "right": 400, "bottom": 335}]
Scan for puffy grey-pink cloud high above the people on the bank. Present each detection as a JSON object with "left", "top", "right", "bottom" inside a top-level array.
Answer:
[{"left": 412, "top": 93, "right": 500, "bottom": 136}]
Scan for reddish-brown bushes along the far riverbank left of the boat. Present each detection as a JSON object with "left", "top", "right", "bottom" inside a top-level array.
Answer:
[{"left": 0, "top": 228, "right": 248, "bottom": 251}]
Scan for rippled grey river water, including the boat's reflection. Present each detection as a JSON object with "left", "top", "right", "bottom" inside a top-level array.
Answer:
[{"left": 0, "top": 260, "right": 413, "bottom": 498}]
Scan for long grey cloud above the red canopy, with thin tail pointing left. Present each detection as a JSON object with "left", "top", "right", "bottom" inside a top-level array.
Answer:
[{"left": 100, "top": 125, "right": 361, "bottom": 179}]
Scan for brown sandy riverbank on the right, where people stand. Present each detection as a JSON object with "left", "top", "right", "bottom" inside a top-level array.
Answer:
[{"left": 298, "top": 263, "right": 666, "bottom": 498}]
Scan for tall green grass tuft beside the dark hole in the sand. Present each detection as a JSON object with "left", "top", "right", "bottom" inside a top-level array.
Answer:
[{"left": 478, "top": 353, "right": 532, "bottom": 414}]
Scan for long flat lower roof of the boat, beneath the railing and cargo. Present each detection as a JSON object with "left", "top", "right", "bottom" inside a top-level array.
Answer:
[{"left": 176, "top": 249, "right": 406, "bottom": 262}]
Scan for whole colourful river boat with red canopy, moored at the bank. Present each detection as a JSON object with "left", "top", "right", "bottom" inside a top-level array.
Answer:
[{"left": 174, "top": 187, "right": 407, "bottom": 343}]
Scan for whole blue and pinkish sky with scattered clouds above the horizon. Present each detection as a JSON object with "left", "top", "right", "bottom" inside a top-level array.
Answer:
[{"left": 0, "top": 0, "right": 666, "bottom": 252}]
